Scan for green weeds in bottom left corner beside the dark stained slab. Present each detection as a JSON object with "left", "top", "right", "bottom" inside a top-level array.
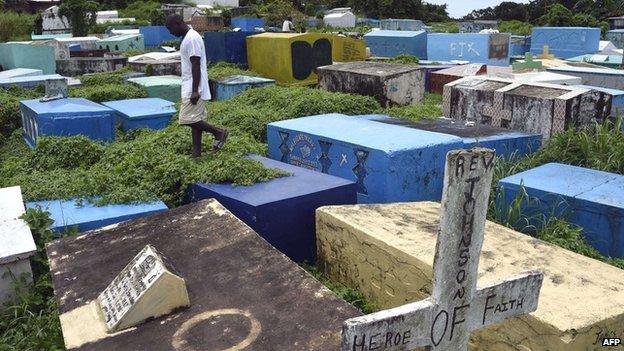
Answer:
[{"left": 0, "top": 209, "right": 65, "bottom": 351}]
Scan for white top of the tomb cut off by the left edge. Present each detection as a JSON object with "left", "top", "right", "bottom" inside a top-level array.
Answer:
[{"left": 0, "top": 186, "right": 37, "bottom": 264}]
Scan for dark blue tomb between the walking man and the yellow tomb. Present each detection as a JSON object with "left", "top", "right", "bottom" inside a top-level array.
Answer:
[{"left": 204, "top": 31, "right": 257, "bottom": 66}]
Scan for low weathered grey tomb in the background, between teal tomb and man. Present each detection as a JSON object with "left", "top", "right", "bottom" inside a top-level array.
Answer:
[{"left": 56, "top": 54, "right": 128, "bottom": 77}]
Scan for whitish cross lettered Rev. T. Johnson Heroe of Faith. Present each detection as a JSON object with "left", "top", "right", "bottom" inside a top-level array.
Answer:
[{"left": 342, "top": 148, "right": 543, "bottom": 351}]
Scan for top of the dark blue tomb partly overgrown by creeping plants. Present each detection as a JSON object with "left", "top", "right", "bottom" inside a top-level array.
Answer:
[{"left": 199, "top": 155, "right": 354, "bottom": 206}]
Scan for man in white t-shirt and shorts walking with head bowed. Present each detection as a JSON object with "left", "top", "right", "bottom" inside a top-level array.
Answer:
[{"left": 165, "top": 14, "right": 228, "bottom": 158}]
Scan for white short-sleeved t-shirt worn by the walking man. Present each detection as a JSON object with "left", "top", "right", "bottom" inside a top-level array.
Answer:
[{"left": 180, "top": 28, "right": 210, "bottom": 101}]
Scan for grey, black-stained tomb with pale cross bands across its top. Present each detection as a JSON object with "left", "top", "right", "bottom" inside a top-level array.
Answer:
[{"left": 442, "top": 77, "right": 611, "bottom": 140}]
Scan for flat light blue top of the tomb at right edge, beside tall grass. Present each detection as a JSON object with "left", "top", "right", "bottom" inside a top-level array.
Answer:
[{"left": 500, "top": 163, "right": 617, "bottom": 197}]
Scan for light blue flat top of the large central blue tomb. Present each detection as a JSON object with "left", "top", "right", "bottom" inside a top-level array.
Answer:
[{"left": 269, "top": 113, "right": 462, "bottom": 152}]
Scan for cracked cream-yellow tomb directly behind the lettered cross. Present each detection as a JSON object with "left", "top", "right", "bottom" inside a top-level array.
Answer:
[{"left": 317, "top": 202, "right": 624, "bottom": 351}]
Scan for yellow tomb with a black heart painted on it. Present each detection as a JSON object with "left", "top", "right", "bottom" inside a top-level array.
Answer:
[{"left": 247, "top": 33, "right": 366, "bottom": 85}]
